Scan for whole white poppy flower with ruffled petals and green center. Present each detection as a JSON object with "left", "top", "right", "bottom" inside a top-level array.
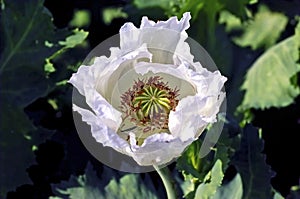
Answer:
[{"left": 69, "top": 13, "right": 226, "bottom": 166}]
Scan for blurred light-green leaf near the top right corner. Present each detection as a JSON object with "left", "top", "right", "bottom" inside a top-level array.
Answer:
[{"left": 233, "top": 6, "right": 288, "bottom": 50}]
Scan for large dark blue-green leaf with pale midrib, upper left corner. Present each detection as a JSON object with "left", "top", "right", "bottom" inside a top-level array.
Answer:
[{"left": 0, "top": 0, "right": 63, "bottom": 133}]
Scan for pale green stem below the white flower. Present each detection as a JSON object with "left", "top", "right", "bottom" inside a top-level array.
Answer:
[{"left": 153, "top": 165, "right": 179, "bottom": 199}]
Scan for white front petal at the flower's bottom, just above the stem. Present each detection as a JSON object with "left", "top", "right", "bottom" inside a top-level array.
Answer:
[{"left": 130, "top": 133, "right": 193, "bottom": 166}]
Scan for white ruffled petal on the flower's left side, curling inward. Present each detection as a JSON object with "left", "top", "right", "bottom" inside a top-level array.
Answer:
[{"left": 69, "top": 45, "right": 152, "bottom": 130}]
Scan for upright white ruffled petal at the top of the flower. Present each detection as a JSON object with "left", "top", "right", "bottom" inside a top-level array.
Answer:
[{"left": 120, "top": 13, "right": 191, "bottom": 64}]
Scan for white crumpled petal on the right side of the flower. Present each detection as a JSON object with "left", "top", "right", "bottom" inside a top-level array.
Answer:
[{"left": 169, "top": 58, "right": 226, "bottom": 141}]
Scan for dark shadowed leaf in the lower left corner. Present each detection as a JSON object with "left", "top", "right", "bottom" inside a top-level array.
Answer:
[{"left": 0, "top": 128, "right": 52, "bottom": 198}]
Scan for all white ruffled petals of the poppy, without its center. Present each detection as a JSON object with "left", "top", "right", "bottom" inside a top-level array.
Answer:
[{"left": 69, "top": 13, "right": 226, "bottom": 166}]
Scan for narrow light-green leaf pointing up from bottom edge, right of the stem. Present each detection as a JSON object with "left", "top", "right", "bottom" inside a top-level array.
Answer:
[{"left": 195, "top": 160, "right": 224, "bottom": 199}]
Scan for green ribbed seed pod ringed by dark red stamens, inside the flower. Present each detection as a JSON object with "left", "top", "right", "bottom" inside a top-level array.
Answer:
[{"left": 118, "top": 76, "right": 179, "bottom": 145}]
